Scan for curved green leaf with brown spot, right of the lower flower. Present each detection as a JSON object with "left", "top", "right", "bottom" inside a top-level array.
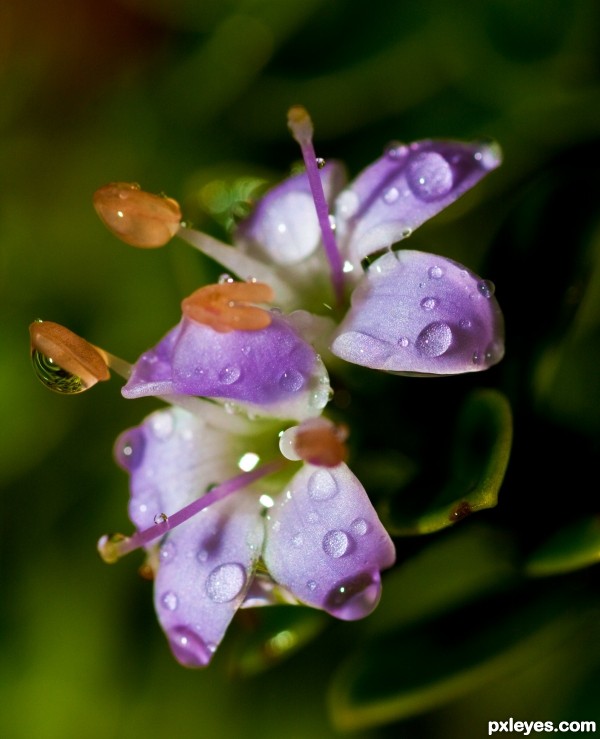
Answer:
[{"left": 381, "top": 390, "right": 512, "bottom": 536}]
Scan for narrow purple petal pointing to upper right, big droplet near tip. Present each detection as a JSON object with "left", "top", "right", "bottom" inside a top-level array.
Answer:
[{"left": 336, "top": 141, "right": 501, "bottom": 266}]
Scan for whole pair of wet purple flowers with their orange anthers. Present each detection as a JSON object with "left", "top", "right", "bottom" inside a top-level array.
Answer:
[{"left": 32, "top": 108, "right": 504, "bottom": 667}]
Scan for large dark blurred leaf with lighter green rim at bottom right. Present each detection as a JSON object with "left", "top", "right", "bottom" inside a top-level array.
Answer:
[{"left": 329, "top": 588, "right": 598, "bottom": 730}]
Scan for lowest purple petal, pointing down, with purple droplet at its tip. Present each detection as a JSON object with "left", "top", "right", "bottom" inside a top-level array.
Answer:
[{"left": 154, "top": 491, "right": 264, "bottom": 667}]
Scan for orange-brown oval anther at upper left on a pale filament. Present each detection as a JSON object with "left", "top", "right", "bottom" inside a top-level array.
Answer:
[{"left": 94, "top": 182, "right": 181, "bottom": 249}]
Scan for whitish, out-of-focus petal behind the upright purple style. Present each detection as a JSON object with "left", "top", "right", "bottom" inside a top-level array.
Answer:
[{"left": 235, "top": 162, "right": 346, "bottom": 265}]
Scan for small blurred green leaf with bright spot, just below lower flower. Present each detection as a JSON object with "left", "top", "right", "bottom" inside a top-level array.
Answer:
[{"left": 231, "top": 605, "right": 329, "bottom": 677}]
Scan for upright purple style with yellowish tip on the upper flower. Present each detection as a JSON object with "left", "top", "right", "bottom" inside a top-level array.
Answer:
[{"left": 288, "top": 105, "right": 344, "bottom": 305}]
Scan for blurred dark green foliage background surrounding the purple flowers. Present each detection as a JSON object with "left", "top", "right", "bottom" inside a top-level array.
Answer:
[{"left": 0, "top": 0, "right": 600, "bottom": 739}]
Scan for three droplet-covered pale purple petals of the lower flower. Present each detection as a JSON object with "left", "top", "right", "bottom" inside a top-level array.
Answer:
[{"left": 116, "top": 409, "right": 395, "bottom": 667}]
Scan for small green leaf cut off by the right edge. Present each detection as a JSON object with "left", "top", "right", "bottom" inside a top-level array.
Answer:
[{"left": 525, "top": 516, "right": 600, "bottom": 577}]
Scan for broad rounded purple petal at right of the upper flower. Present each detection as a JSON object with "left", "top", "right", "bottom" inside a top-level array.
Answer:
[{"left": 331, "top": 250, "right": 504, "bottom": 375}]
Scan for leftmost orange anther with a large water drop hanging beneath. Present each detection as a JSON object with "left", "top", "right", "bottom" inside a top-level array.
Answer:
[{"left": 29, "top": 321, "right": 110, "bottom": 395}]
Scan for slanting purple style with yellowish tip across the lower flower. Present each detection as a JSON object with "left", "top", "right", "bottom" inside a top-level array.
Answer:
[{"left": 98, "top": 461, "right": 285, "bottom": 564}]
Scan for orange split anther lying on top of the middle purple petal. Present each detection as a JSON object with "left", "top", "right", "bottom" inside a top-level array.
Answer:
[{"left": 181, "top": 282, "right": 274, "bottom": 333}]
